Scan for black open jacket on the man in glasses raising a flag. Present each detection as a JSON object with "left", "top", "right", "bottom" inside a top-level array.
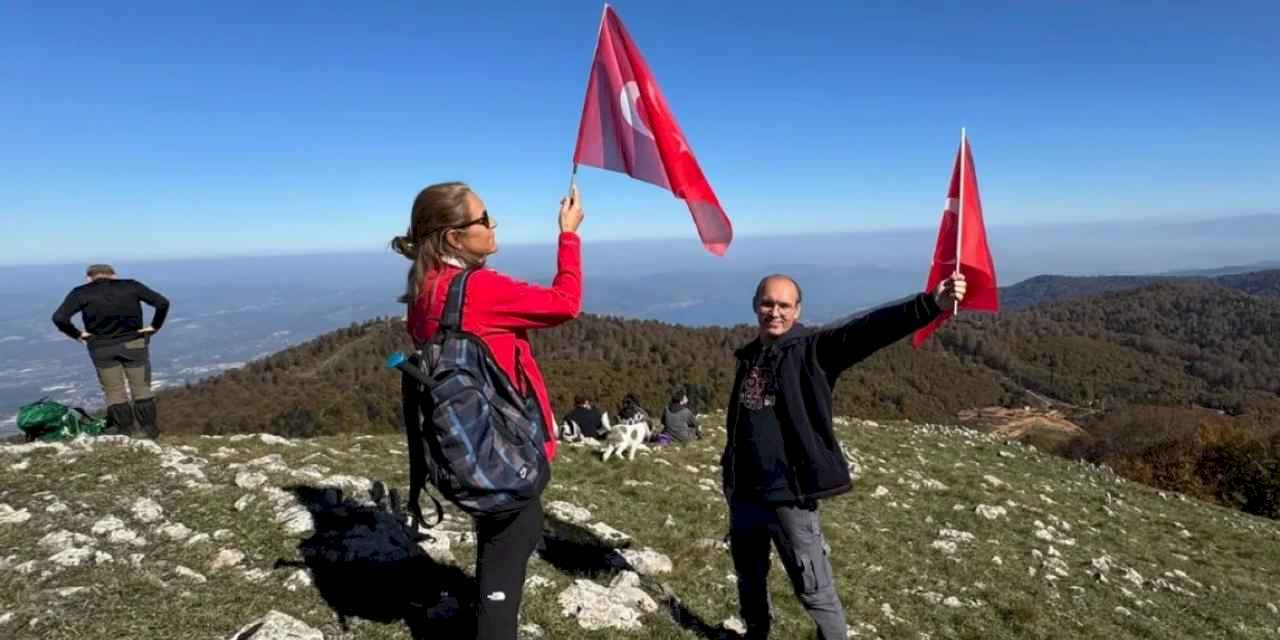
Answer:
[{"left": 721, "top": 293, "right": 942, "bottom": 500}]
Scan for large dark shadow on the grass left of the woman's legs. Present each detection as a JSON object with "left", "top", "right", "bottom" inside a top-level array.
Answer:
[{"left": 275, "top": 486, "right": 476, "bottom": 640}]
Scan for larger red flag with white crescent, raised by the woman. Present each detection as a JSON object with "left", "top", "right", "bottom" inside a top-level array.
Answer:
[{"left": 573, "top": 5, "right": 733, "bottom": 256}]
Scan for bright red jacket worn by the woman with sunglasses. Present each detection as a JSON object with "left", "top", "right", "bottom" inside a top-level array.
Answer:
[{"left": 408, "top": 233, "right": 582, "bottom": 460}]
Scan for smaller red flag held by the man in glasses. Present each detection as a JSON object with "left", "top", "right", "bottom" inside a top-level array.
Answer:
[{"left": 911, "top": 132, "right": 1000, "bottom": 347}]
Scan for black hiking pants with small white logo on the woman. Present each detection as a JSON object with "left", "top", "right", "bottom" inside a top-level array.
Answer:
[{"left": 475, "top": 498, "right": 543, "bottom": 640}]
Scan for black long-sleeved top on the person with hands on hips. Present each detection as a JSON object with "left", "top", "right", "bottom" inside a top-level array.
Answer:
[{"left": 54, "top": 278, "right": 169, "bottom": 347}]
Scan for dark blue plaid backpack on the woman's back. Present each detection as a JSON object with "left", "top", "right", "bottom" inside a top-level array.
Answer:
[{"left": 388, "top": 269, "right": 550, "bottom": 521}]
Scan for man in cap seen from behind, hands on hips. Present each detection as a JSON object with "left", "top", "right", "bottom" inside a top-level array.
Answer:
[{"left": 54, "top": 265, "right": 169, "bottom": 438}]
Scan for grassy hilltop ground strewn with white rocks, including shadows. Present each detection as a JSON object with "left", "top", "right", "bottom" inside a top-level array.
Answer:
[{"left": 0, "top": 419, "right": 1280, "bottom": 640}]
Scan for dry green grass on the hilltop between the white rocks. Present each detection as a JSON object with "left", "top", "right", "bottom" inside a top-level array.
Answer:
[{"left": 0, "top": 421, "right": 1280, "bottom": 640}]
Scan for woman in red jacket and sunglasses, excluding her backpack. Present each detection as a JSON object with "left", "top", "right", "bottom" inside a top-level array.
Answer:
[{"left": 392, "top": 182, "right": 582, "bottom": 640}]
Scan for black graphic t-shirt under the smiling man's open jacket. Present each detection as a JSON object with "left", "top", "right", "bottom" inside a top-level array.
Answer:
[{"left": 733, "top": 348, "right": 796, "bottom": 502}]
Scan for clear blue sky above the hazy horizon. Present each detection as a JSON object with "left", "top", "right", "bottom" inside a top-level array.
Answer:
[{"left": 0, "top": 0, "right": 1280, "bottom": 264}]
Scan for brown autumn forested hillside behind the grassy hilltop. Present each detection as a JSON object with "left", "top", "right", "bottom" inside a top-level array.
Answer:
[{"left": 152, "top": 271, "right": 1280, "bottom": 515}]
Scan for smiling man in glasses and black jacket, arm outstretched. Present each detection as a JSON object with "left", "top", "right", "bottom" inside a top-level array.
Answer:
[{"left": 721, "top": 275, "right": 965, "bottom": 640}]
